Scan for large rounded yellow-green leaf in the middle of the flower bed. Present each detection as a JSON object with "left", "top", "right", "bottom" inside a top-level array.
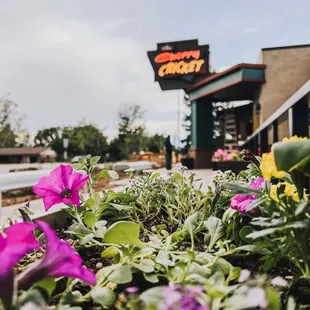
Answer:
[{"left": 104, "top": 221, "right": 145, "bottom": 248}]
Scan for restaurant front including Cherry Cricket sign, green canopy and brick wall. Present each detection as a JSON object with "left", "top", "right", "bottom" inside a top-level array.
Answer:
[{"left": 148, "top": 40, "right": 310, "bottom": 169}]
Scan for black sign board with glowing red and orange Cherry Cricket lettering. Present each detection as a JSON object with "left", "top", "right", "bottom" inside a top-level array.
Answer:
[{"left": 147, "top": 40, "right": 209, "bottom": 90}]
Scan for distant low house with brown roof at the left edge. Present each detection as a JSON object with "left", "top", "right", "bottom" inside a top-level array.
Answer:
[{"left": 0, "top": 147, "right": 56, "bottom": 164}]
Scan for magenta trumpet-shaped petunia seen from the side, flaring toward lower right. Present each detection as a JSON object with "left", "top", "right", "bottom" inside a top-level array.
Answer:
[{"left": 18, "top": 221, "right": 96, "bottom": 289}]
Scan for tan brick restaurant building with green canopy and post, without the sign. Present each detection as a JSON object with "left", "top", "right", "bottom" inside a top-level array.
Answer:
[{"left": 149, "top": 41, "right": 310, "bottom": 169}]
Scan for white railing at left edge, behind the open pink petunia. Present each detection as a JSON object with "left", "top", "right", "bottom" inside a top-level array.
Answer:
[{"left": 0, "top": 170, "right": 50, "bottom": 219}]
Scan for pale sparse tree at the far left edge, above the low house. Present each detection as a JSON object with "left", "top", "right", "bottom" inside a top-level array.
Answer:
[{"left": 0, "top": 97, "right": 24, "bottom": 147}]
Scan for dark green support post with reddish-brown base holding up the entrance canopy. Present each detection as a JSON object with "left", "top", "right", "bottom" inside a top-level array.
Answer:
[{"left": 189, "top": 98, "right": 213, "bottom": 169}]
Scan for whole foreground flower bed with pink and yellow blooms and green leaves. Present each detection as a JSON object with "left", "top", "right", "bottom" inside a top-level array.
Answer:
[{"left": 0, "top": 138, "right": 310, "bottom": 310}]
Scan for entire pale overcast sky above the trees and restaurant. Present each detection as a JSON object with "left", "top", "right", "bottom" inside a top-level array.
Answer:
[{"left": 0, "top": 0, "right": 310, "bottom": 140}]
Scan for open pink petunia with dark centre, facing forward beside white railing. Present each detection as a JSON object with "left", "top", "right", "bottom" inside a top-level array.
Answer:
[{"left": 33, "top": 165, "right": 88, "bottom": 211}]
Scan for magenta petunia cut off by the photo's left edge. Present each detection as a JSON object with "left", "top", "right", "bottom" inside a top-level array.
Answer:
[{"left": 0, "top": 223, "right": 40, "bottom": 306}]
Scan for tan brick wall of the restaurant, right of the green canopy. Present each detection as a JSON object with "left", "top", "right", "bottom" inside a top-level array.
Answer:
[{"left": 259, "top": 46, "right": 310, "bottom": 124}]
